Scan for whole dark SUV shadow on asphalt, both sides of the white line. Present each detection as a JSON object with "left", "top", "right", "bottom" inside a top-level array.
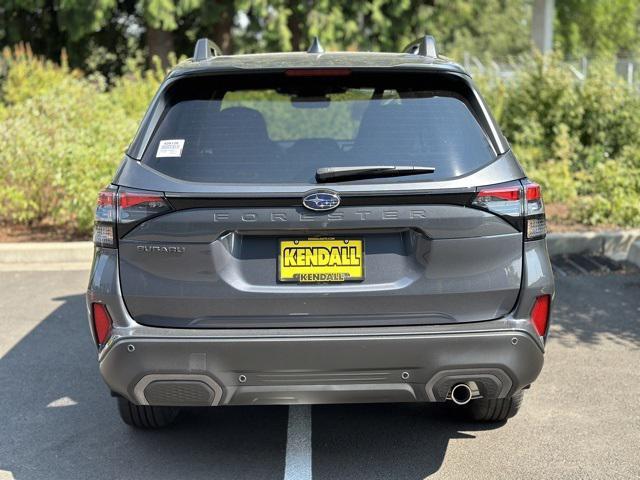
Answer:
[{"left": 0, "top": 295, "right": 528, "bottom": 480}]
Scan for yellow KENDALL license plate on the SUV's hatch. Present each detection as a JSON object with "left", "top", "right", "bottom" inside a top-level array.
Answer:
[{"left": 278, "top": 238, "right": 364, "bottom": 283}]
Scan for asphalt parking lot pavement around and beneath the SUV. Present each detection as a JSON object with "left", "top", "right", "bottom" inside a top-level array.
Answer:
[{"left": 0, "top": 270, "right": 640, "bottom": 480}]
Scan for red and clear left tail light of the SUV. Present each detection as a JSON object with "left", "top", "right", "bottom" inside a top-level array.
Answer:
[{"left": 93, "top": 186, "right": 171, "bottom": 248}]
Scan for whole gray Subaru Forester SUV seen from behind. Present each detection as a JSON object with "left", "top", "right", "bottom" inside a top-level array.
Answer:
[{"left": 87, "top": 36, "right": 554, "bottom": 427}]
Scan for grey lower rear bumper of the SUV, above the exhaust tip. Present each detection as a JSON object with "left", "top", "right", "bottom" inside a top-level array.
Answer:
[{"left": 100, "top": 323, "right": 543, "bottom": 406}]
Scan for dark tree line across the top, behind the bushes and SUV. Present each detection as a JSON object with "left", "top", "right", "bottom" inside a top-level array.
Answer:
[{"left": 6, "top": 0, "right": 640, "bottom": 77}]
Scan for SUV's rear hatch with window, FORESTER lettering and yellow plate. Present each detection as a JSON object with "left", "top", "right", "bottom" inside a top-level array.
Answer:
[{"left": 115, "top": 69, "right": 523, "bottom": 328}]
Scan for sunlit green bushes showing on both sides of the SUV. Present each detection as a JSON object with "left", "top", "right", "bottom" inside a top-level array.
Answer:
[{"left": 0, "top": 47, "right": 640, "bottom": 233}]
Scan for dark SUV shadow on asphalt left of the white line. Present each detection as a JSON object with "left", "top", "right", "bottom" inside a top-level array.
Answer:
[{"left": 0, "top": 295, "right": 288, "bottom": 480}]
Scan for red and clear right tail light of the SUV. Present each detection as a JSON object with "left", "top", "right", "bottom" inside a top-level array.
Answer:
[{"left": 473, "top": 181, "right": 547, "bottom": 240}]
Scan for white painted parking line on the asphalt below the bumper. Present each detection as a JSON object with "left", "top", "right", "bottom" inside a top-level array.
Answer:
[{"left": 284, "top": 405, "right": 311, "bottom": 480}]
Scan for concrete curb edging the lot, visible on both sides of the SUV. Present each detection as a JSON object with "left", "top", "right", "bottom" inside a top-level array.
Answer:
[{"left": 0, "top": 235, "right": 640, "bottom": 271}]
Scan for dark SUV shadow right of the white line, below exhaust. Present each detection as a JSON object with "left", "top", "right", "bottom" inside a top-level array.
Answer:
[{"left": 313, "top": 404, "right": 504, "bottom": 480}]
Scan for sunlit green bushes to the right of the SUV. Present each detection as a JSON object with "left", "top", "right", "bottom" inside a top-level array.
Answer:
[{"left": 477, "top": 56, "right": 640, "bottom": 226}]
